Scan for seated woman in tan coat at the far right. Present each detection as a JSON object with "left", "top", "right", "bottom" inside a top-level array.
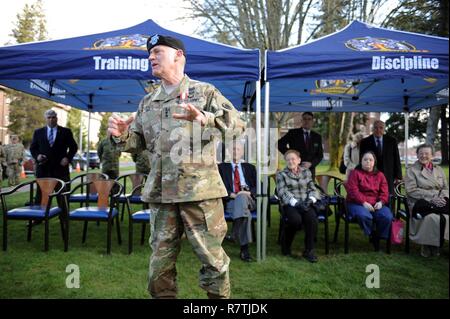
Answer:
[{"left": 405, "top": 144, "right": 448, "bottom": 257}]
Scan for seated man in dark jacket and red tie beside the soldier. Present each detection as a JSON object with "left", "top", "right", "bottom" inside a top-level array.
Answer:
[{"left": 219, "top": 141, "right": 256, "bottom": 262}]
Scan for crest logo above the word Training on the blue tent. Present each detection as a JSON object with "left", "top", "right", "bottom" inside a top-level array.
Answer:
[{"left": 85, "top": 34, "right": 148, "bottom": 50}]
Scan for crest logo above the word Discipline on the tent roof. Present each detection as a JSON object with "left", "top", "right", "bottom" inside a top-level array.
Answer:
[{"left": 345, "top": 37, "right": 428, "bottom": 52}]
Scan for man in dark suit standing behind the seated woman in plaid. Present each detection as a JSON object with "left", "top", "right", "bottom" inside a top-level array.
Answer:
[{"left": 278, "top": 112, "right": 323, "bottom": 180}]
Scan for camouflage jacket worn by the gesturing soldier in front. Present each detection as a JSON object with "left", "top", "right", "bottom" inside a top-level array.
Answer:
[{"left": 113, "top": 75, "right": 244, "bottom": 203}]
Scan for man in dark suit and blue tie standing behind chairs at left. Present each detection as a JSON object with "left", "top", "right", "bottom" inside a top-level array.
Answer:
[{"left": 30, "top": 109, "right": 78, "bottom": 182}]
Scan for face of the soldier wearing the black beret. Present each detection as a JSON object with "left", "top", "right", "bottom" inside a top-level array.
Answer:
[{"left": 148, "top": 45, "right": 181, "bottom": 78}]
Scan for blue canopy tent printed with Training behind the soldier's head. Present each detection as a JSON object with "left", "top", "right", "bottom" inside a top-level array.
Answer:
[{"left": 0, "top": 20, "right": 259, "bottom": 112}]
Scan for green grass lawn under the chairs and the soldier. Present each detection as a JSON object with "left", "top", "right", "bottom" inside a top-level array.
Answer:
[{"left": 0, "top": 167, "right": 449, "bottom": 299}]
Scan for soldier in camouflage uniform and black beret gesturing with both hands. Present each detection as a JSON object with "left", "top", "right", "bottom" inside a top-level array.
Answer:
[{"left": 108, "top": 35, "right": 243, "bottom": 298}]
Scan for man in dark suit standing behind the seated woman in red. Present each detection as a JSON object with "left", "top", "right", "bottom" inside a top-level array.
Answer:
[{"left": 359, "top": 120, "right": 402, "bottom": 195}]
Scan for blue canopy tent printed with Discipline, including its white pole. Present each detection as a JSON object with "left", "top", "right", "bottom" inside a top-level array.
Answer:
[{"left": 253, "top": 21, "right": 448, "bottom": 259}]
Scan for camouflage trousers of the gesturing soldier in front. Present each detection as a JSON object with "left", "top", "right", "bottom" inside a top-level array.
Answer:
[{"left": 148, "top": 198, "right": 230, "bottom": 298}]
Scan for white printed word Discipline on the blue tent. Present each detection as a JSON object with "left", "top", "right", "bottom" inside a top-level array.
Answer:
[{"left": 372, "top": 55, "right": 439, "bottom": 71}]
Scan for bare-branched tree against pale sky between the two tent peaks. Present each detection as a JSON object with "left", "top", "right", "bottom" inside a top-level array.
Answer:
[{"left": 185, "top": 0, "right": 314, "bottom": 50}]
